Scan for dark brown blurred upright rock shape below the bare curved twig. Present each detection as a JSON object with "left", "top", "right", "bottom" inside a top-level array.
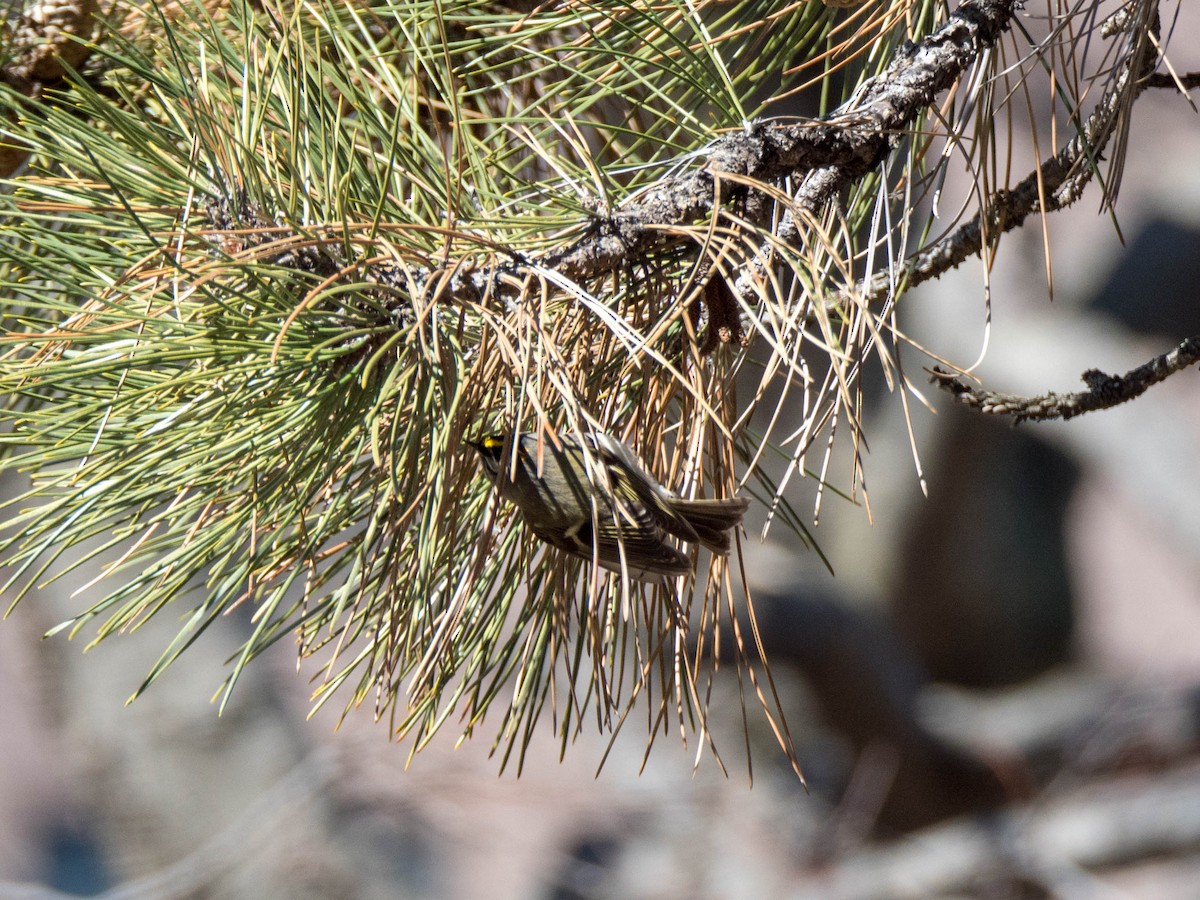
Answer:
[{"left": 890, "top": 415, "right": 1078, "bottom": 686}]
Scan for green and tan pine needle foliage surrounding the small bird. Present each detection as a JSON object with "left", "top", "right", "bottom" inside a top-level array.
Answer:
[{"left": 0, "top": 0, "right": 1180, "bottom": 761}]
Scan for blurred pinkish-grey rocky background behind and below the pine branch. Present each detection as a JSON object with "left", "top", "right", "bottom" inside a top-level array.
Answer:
[{"left": 7, "top": 10, "right": 1200, "bottom": 900}]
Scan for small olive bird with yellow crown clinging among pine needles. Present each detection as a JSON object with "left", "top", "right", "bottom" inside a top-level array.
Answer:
[{"left": 469, "top": 433, "right": 750, "bottom": 581}]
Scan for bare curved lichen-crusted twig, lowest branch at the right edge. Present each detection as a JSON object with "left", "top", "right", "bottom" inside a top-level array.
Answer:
[{"left": 931, "top": 337, "right": 1200, "bottom": 425}]
